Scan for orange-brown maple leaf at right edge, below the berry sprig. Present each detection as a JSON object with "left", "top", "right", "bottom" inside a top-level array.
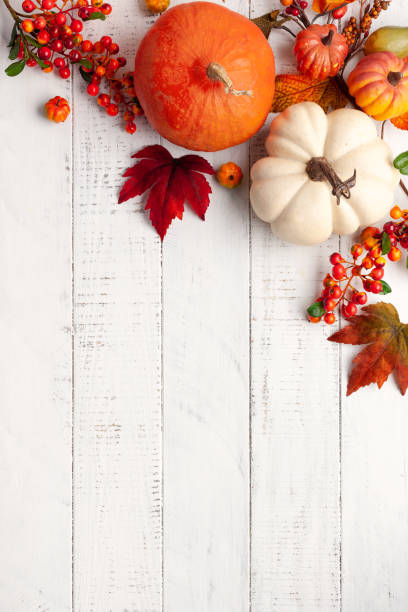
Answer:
[{"left": 329, "top": 302, "right": 408, "bottom": 395}]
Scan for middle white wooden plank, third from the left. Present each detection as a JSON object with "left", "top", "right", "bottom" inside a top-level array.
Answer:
[{"left": 163, "top": 0, "right": 249, "bottom": 596}]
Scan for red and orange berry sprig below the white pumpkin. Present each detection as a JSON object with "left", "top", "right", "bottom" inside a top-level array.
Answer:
[{"left": 307, "top": 206, "right": 408, "bottom": 325}]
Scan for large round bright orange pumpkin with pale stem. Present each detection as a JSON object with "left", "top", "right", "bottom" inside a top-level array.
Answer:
[{"left": 134, "top": 2, "right": 275, "bottom": 151}]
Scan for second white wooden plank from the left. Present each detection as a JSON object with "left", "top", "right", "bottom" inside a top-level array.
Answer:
[{"left": 74, "top": 1, "right": 162, "bottom": 612}]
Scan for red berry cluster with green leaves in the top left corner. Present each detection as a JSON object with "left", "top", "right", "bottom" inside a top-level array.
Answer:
[{"left": 6, "top": 0, "right": 143, "bottom": 134}]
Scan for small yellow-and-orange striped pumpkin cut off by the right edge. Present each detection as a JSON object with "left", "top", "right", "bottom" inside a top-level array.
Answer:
[{"left": 347, "top": 51, "right": 408, "bottom": 121}]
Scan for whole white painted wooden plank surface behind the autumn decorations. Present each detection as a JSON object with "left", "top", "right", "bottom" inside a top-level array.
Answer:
[{"left": 0, "top": 0, "right": 408, "bottom": 612}]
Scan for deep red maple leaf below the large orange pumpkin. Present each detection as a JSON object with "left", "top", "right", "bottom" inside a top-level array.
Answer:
[{"left": 118, "top": 145, "right": 215, "bottom": 240}]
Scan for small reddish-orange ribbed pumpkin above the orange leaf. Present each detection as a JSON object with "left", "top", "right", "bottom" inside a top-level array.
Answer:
[{"left": 294, "top": 25, "right": 349, "bottom": 81}]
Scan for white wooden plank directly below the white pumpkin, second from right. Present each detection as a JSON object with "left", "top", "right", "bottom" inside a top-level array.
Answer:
[{"left": 251, "top": 9, "right": 341, "bottom": 612}]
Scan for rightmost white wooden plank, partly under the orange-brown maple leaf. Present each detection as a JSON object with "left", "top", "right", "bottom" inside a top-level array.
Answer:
[{"left": 342, "top": 9, "right": 408, "bottom": 612}]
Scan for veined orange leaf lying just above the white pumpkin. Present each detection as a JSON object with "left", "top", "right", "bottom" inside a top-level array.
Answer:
[{"left": 271, "top": 74, "right": 347, "bottom": 113}]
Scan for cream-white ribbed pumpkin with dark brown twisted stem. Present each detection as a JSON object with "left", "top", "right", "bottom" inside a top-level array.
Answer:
[{"left": 251, "top": 102, "right": 399, "bottom": 244}]
